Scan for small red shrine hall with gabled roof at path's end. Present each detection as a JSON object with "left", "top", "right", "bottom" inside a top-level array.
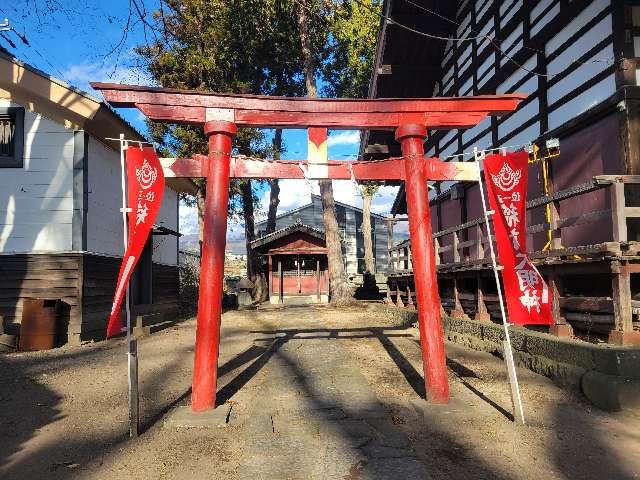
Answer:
[{"left": 251, "top": 223, "right": 329, "bottom": 305}]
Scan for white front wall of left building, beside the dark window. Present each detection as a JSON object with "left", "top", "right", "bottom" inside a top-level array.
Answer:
[{"left": 0, "top": 99, "right": 73, "bottom": 252}]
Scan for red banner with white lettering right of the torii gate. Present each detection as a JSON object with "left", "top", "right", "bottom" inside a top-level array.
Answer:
[{"left": 484, "top": 152, "right": 553, "bottom": 325}]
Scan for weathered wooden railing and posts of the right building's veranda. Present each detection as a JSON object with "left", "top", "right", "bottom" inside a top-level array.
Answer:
[{"left": 389, "top": 175, "right": 640, "bottom": 344}]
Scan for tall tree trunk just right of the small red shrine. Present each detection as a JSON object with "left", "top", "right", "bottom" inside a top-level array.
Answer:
[{"left": 297, "top": 2, "right": 353, "bottom": 304}]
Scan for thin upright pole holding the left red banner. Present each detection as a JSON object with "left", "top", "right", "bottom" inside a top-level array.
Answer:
[{"left": 120, "top": 133, "right": 139, "bottom": 437}]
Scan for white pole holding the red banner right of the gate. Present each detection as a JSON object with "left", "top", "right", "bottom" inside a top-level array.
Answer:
[{"left": 473, "top": 147, "right": 525, "bottom": 425}]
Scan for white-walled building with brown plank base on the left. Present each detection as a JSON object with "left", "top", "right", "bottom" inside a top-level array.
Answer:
[{"left": 0, "top": 50, "right": 189, "bottom": 341}]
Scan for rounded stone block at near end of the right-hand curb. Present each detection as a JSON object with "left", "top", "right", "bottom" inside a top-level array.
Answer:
[{"left": 581, "top": 370, "right": 640, "bottom": 412}]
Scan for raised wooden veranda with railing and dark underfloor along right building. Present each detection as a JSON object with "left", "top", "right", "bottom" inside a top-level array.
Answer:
[{"left": 388, "top": 175, "right": 640, "bottom": 343}]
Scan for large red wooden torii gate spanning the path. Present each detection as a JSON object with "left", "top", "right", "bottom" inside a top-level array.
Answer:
[{"left": 91, "top": 83, "right": 526, "bottom": 411}]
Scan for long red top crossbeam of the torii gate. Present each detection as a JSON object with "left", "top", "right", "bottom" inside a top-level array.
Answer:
[{"left": 91, "top": 83, "right": 525, "bottom": 130}]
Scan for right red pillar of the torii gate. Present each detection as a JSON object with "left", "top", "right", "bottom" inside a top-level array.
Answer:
[{"left": 396, "top": 124, "right": 449, "bottom": 403}]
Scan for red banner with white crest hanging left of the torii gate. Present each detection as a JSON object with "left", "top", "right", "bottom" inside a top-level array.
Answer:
[{"left": 107, "top": 146, "right": 164, "bottom": 338}]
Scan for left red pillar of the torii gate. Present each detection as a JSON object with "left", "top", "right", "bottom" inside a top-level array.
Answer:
[{"left": 191, "top": 121, "right": 236, "bottom": 412}]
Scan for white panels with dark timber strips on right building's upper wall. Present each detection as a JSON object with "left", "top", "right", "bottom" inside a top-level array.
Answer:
[{"left": 428, "top": 0, "right": 617, "bottom": 156}]
